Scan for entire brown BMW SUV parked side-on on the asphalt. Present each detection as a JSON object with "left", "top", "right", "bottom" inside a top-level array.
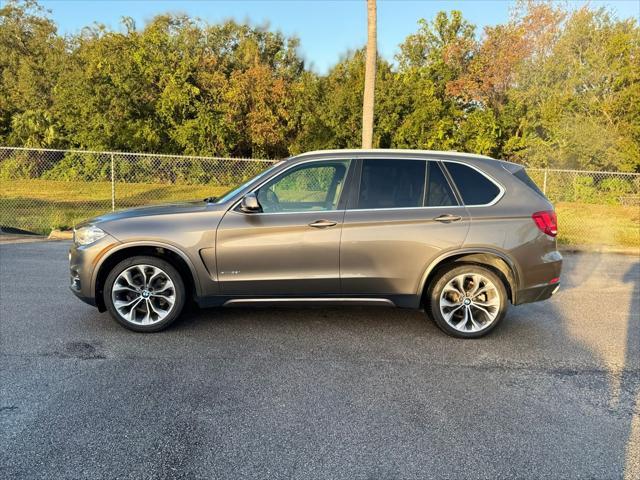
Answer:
[{"left": 69, "top": 150, "right": 562, "bottom": 338}]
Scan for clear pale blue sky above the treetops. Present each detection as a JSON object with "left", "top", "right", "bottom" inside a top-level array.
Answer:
[{"left": 38, "top": 0, "right": 640, "bottom": 74}]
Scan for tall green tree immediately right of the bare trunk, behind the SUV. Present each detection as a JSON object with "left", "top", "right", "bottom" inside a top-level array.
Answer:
[{"left": 392, "top": 11, "right": 498, "bottom": 154}]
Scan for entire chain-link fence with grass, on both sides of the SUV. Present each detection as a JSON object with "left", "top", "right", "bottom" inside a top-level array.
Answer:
[{"left": 0, "top": 147, "right": 640, "bottom": 248}]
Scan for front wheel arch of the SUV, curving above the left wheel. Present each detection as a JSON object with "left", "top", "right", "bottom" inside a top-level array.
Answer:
[{"left": 91, "top": 242, "right": 200, "bottom": 312}]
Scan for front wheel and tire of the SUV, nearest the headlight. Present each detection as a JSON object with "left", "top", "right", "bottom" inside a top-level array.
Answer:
[{"left": 103, "top": 256, "right": 186, "bottom": 332}]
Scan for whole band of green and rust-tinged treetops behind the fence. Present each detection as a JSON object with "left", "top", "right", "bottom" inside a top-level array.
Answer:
[{"left": 0, "top": 0, "right": 640, "bottom": 172}]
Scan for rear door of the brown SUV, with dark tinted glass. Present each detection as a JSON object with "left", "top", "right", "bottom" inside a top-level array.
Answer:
[{"left": 340, "top": 158, "right": 469, "bottom": 296}]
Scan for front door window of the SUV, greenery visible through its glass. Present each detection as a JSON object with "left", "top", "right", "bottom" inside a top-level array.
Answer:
[{"left": 256, "top": 161, "right": 349, "bottom": 213}]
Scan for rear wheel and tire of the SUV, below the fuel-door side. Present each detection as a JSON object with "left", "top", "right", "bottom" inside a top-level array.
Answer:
[{"left": 427, "top": 264, "right": 508, "bottom": 338}]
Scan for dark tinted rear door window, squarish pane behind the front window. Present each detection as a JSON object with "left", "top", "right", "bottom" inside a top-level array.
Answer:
[{"left": 358, "top": 159, "right": 427, "bottom": 209}]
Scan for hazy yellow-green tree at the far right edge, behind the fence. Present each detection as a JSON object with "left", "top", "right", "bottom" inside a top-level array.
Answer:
[{"left": 505, "top": 7, "right": 640, "bottom": 171}]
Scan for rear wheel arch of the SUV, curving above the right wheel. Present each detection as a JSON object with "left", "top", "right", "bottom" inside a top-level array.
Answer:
[{"left": 418, "top": 248, "right": 520, "bottom": 304}]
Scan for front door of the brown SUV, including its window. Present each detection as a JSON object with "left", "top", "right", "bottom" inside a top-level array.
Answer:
[{"left": 216, "top": 160, "right": 350, "bottom": 297}]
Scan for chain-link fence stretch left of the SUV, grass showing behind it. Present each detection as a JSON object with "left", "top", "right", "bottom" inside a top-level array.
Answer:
[{"left": 0, "top": 147, "right": 274, "bottom": 233}]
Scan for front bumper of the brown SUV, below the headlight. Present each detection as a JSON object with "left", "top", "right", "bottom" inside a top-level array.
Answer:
[{"left": 69, "top": 235, "right": 119, "bottom": 306}]
